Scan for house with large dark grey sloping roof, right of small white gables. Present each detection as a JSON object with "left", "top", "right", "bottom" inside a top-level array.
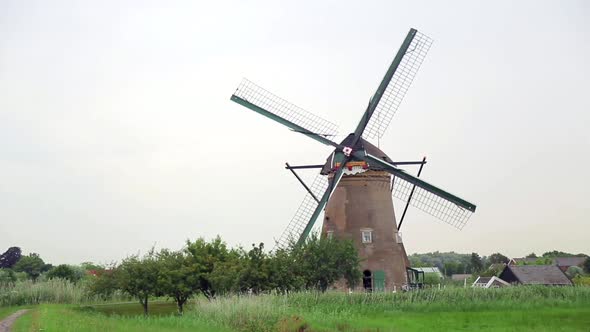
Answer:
[{"left": 499, "top": 265, "right": 572, "bottom": 286}]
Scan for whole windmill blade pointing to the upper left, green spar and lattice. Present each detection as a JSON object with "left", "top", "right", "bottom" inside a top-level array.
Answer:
[{"left": 230, "top": 79, "right": 338, "bottom": 147}]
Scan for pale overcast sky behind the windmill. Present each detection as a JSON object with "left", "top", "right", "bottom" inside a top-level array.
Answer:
[{"left": 0, "top": 0, "right": 590, "bottom": 264}]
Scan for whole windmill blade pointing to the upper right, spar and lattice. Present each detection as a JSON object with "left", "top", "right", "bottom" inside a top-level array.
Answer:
[{"left": 355, "top": 29, "right": 432, "bottom": 139}]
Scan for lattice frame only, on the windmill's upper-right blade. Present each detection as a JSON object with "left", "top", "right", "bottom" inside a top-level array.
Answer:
[{"left": 363, "top": 32, "right": 433, "bottom": 138}]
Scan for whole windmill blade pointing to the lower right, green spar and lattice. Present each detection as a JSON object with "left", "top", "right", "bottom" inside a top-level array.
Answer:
[{"left": 366, "top": 154, "right": 476, "bottom": 229}]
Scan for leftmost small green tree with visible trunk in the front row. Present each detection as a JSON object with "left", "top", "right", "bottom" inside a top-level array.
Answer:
[{"left": 115, "top": 248, "right": 162, "bottom": 316}]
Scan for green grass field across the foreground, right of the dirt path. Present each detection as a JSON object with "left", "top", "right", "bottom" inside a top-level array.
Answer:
[{"left": 6, "top": 287, "right": 590, "bottom": 332}]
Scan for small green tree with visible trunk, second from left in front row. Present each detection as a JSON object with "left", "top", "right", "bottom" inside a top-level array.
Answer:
[{"left": 158, "top": 249, "right": 200, "bottom": 315}]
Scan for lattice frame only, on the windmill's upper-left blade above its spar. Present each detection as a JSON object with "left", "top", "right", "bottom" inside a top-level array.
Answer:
[{"left": 234, "top": 78, "right": 338, "bottom": 137}]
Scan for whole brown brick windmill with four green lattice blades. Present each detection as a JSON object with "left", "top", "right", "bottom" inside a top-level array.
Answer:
[{"left": 231, "top": 29, "right": 476, "bottom": 290}]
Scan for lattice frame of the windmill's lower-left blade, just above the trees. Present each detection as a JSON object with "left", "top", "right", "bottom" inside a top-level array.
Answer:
[{"left": 275, "top": 174, "right": 329, "bottom": 248}]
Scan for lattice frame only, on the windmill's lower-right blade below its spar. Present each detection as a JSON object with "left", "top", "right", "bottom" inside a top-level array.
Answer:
[{"left": 391, "top": 175, "right": 473, "bottom": 229}]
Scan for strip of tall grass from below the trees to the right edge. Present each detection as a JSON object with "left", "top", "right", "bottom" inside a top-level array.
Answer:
[{"left": 185, "top": 286, "right": 590, "bottom": 331}]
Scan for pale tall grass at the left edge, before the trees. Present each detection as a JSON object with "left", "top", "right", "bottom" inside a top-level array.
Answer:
[{"left": 0, "top": 279, "right": 128, "bottom": 306}]
